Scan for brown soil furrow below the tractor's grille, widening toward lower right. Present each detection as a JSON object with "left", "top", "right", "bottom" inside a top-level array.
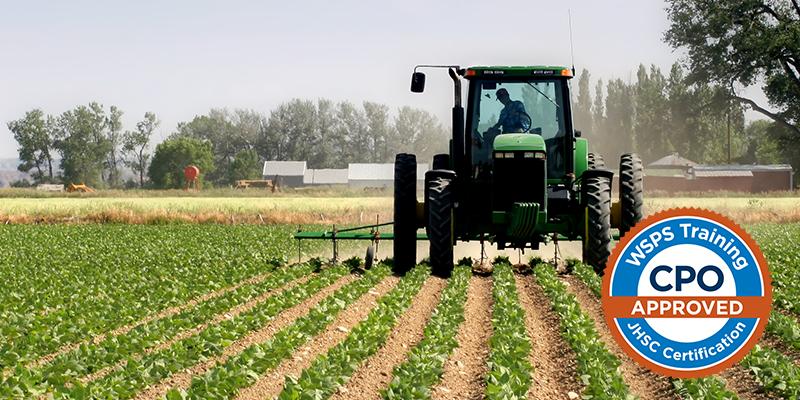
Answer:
[{"left": 516, "top": 275, "right": 583, "bottom": 400}]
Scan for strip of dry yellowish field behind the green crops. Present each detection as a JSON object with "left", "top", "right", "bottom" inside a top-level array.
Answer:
[{"left": 0, "top": 196, "right": 800, "bottom": 224}]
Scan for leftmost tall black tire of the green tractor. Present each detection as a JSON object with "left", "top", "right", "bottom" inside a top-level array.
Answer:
[{"left": 392, "top": 153, "right": 417, "bottom": 274}]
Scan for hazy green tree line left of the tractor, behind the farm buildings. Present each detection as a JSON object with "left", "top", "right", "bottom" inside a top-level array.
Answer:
[{"left": 8, "top": 99, "right": 448, "bottom": 188}]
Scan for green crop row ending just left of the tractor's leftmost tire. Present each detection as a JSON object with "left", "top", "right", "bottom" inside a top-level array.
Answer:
[{"left": 173, "top": 264, "right": 390, "bottom": 399}]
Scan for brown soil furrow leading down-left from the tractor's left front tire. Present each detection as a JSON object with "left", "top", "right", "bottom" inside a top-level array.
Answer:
[{"left": 332, "top": 277, "right": 447, "bottom": 400}]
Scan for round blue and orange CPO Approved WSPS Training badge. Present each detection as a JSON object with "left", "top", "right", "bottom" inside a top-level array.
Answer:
[{"left": 603, "top": 209, "right": 772, "bottom": 378}]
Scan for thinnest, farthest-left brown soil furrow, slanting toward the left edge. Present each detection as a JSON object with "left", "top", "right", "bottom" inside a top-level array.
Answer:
[{"left": 20, "top": 272, "right": 280, "bottom": 375}]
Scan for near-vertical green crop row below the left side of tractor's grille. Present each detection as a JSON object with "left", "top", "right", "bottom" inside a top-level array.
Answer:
[{"left": 486, "top": 259, "right": 533, "bottom": 399}]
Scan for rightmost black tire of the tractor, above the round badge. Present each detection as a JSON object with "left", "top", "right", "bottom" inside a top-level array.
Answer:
[{"left": 619, "top": 153, "right": 644, "bottom": 237}]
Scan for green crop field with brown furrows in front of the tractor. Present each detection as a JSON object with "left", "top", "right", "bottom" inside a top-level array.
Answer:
[{"left": 0, "top": 223, "right": 800, "bottom": 399}]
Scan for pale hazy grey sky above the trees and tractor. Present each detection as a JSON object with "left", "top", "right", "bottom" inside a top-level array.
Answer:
[{"left": 0, "top": 0, "right": 708, "bottom": 157}]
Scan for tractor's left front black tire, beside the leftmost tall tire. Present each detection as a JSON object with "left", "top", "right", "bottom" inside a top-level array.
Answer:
[{"left": 425, "top": 170, "right": 455, "bottom": 278}]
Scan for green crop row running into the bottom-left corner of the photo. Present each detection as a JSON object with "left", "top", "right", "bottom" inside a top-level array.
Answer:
[{"left": 0, "top": 263, "right": 314, "bottom": 393}]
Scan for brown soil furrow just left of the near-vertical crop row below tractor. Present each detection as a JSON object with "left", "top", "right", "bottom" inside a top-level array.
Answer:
[{"left": 432, "top": 276, "right": 494, "bottom": 400}]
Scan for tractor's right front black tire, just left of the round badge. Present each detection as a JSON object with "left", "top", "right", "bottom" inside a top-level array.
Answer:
[{"left": 583, "top": 177, "right": 611, "bottom": 275}]
